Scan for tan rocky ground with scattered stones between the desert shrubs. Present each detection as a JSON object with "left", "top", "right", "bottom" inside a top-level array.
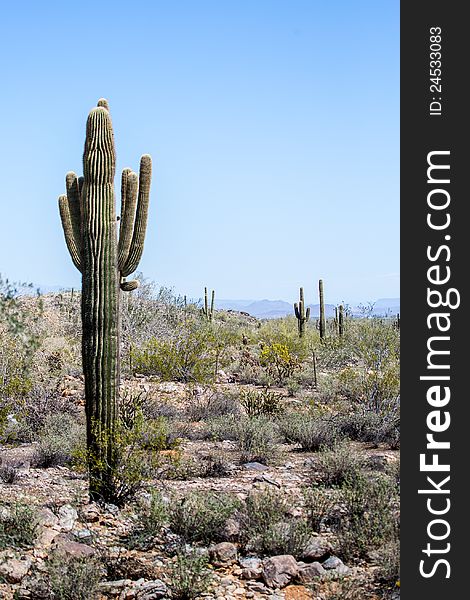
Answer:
[{"left": 0, "top": 378, "right": 398, "bottom": 600}]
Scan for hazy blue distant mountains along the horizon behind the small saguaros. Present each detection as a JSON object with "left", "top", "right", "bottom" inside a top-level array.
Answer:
[{"left": 215, "top": 298, "right": 400, "bottom": 319}]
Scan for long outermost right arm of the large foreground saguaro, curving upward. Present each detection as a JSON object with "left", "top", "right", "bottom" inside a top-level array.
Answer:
[{"left": 121, "top": 154, "right": 152, "bottom": 277}]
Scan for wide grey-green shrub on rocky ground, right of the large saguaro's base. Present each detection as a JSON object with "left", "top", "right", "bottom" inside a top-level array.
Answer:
[{"left": 169, "top": 491, "right": 239, "bottom": 544}]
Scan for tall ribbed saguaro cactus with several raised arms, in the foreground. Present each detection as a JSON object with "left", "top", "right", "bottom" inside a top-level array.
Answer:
[{"left": 59, "top": 99, "right": 152, "bottom": 501}]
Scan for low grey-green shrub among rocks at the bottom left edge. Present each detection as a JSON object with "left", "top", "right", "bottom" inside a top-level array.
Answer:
[{"left": 47, "top": 557, "right": 101, "bottom": 600}]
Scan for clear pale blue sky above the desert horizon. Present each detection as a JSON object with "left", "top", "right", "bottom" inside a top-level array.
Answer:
[{"left": 0, "top": 0, "right": 399, "bottom": 302}]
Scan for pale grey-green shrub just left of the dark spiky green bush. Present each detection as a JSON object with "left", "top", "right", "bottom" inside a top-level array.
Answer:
[{"left": 185, "top": 387, "right": 241, "bottom": 421}]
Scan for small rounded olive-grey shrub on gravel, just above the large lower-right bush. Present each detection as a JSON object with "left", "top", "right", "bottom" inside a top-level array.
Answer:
[{"left": 316, "top": 443, "right": 364, "bottom": 487}]
